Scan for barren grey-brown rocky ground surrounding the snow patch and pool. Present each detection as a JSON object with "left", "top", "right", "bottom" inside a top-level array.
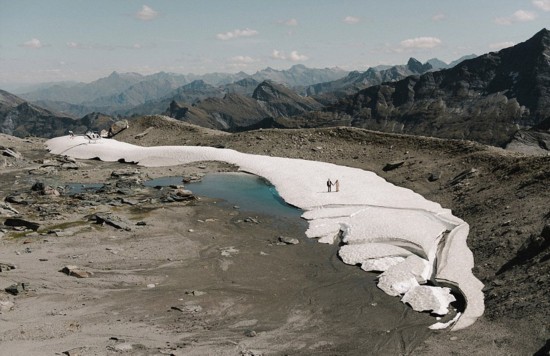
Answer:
[{"left": 0, "top": 116, "right": 550, "bottom": 355}]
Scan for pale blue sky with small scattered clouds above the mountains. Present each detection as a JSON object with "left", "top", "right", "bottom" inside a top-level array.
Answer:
[{"left": 0, "top": 0, "right": 550, "bottom": 90}]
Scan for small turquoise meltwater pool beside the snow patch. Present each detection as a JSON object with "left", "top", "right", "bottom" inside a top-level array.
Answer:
[{"left": 145, "top": 173, "right": 303, "bottom": 217}]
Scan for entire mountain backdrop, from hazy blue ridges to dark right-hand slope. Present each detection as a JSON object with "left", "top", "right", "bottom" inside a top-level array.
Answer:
[{"left": 0, "top": 29, "right": 550, "bottom": 150}]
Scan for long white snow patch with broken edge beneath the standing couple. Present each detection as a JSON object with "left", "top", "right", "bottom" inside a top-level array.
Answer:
[{"left": 46, "top": 136, "right": 484, "bottom": 330}]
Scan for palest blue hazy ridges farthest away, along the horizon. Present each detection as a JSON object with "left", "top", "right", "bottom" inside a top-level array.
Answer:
[{"left": 12, "top": 58, "right": 474, "bottom": 118}]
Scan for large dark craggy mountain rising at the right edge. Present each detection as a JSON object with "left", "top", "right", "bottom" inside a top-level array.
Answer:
[{"left": 322, "top": 29, "right": 550, "bottom": 146}]
